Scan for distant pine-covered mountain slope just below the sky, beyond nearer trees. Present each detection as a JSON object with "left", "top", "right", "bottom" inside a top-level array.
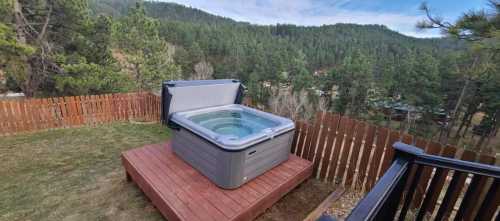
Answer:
[{"left": 91, "top": 0, "right": 462, "bottom": 79}]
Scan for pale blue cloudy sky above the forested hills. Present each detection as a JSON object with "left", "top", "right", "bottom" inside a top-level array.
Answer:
[{"left": 160, "top": 0, "right": 487, "bottom": 38}]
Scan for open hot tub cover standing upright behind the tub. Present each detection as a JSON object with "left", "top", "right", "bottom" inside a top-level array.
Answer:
[{"left": 161, "top": 79, "right": 245, "bottom": 125}]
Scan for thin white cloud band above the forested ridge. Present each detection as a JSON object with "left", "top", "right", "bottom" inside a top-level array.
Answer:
[{"left": 160, "top": 0, "right": 440, "bottom": 37}]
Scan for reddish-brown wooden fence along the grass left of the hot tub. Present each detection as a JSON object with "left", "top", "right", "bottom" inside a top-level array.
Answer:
[{"left": 0, "top": 92, "right": 160, "bottom": 135}]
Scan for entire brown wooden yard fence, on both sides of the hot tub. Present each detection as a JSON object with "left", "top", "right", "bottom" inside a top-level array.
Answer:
[{"left": 0, "top": 92, "right": 500, "bottom": 218}]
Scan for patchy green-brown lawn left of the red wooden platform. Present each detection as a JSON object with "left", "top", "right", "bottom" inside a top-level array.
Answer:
[{"left": 0, "top": 123, "right": 169, "bottom": 220}]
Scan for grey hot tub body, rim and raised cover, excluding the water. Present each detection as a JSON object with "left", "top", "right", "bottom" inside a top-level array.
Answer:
[{"left": 162, "top": 80, "right": 295, "bottom": 189}]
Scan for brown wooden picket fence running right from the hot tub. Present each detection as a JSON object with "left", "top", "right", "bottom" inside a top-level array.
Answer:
[{"left": 292, "top": 112, "right": 496, "bottom": 195}]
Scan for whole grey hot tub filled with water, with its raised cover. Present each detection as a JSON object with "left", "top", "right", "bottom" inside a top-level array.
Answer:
[{"left": 162, "top": 80, "right": 295, "bottom": 189}]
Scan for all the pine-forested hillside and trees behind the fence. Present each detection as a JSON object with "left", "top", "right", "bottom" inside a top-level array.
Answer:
[{"left": 0, "top": 0, "right": 500, "bottom": 152}]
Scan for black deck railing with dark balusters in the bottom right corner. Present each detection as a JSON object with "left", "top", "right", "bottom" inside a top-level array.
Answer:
[{"left": 347, "top": 142, "right": 500, "bottom": 220}]
